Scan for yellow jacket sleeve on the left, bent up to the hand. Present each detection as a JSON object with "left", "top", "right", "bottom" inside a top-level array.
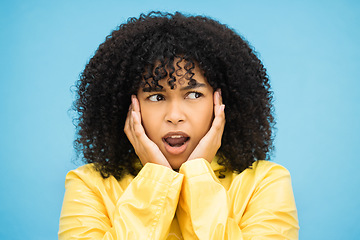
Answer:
[{"left": 59, "top": 163, "right": 183, "bottom": 240}]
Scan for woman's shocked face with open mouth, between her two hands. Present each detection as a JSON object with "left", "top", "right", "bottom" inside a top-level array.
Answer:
[{"left": 137, "top": 61, "right": 214, "bottom": 169}]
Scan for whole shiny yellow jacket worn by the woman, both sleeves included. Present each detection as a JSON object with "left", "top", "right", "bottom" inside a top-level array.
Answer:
[{"left": 59, "top": 159, "right": 299, "bottom": 240}]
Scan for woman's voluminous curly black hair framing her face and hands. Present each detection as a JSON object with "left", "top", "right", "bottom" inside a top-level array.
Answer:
[{"left": 74, "top": 12, "right": 275, "bottom": 179}]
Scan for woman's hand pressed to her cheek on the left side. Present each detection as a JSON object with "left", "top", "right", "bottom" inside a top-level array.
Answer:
[{"left": 124, "top": 95, "right": 171, "bottom": 168}]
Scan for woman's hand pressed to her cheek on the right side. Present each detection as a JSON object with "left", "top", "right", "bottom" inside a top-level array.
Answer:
[{"left": 188, "top": 89, "right": 225, "bottom": 162}]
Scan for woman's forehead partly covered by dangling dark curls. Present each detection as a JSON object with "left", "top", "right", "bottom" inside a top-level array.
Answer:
[{"left": 139, "top": 57, "right": 208, "bottom": 92}]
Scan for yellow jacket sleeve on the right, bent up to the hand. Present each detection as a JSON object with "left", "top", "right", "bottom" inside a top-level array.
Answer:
[{"left": 176, "top": 159, "right": 298, "bottom": 240}]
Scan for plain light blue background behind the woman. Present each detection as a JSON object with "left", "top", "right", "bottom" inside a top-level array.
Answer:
[{"left": 0, "top": 0, "right": 360, "bottom": 240}]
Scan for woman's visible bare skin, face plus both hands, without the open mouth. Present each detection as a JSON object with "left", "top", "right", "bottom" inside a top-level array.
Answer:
[{"left": 124, "top": 62, "right": 225, "bottom": 169}]
